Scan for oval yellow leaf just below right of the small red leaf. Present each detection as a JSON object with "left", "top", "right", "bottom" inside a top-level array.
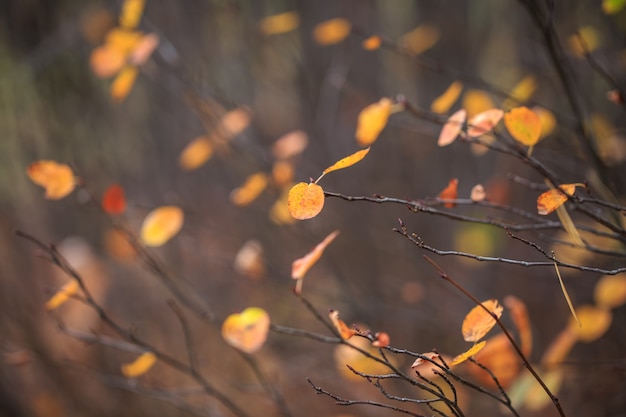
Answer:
[{"left": 140, "top": 206, "right": 184, "bottom": 247}]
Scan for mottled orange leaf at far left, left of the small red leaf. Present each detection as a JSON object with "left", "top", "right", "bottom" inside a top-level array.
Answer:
[{"left": 26, "top": 160, "right": 76, "bottom": 200}]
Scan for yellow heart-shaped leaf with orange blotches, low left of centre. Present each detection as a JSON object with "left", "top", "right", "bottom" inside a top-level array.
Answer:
[{"left": 222, "top": 307, "right": 270, "bottom": 353}]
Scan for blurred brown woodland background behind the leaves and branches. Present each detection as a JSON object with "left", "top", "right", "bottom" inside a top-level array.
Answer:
[{"left": 0, "top": 0, "right": 626, "bottom": 416}]
